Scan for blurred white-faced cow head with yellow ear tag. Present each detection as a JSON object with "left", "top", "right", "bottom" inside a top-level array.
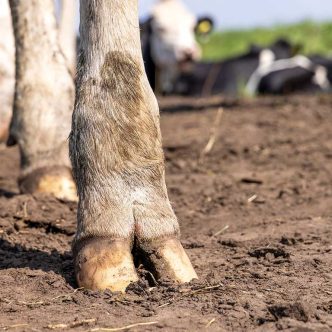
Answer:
[{"left": 140, "top": 0, "right": 213, "bottom": 93}]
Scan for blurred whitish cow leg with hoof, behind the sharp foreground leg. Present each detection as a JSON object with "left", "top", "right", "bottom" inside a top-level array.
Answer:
[{"left": 8, "top": 0, "right": 76, "bottom": 200}]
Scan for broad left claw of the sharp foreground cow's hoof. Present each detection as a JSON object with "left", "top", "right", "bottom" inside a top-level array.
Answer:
[{"left": 74, "top": 238, "right": 138, "bottom": 292}]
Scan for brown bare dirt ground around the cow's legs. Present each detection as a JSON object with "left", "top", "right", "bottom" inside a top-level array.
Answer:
[{"left": 0, "top": 96, "right": 332, "bottom": 332}]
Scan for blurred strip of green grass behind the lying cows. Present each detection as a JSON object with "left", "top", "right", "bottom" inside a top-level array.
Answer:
[{"left": 201, "top": 21, "right": 332, "bottom": 61}]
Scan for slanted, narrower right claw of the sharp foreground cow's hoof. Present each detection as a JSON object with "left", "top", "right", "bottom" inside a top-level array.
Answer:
[{"left": 140, "top": 238, "right": 198, "bottom": 283}]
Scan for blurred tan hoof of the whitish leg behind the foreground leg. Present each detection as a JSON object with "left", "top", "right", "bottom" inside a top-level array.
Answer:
[{"left": 19, "top": 167, "right": 78, "bottom": 202}]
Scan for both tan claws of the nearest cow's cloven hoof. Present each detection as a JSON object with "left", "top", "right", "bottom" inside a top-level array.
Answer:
[{"left": 74, "top": 238, "right": 197, "bottom": 292}]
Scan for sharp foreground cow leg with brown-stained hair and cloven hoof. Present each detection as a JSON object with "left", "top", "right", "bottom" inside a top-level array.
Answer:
[{"left": 70, "top": 0, "right": 197, "bottom": 291}]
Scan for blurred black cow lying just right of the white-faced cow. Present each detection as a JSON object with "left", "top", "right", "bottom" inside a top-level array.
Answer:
[{"left": 172, "top": 39, "right": 294, "bottom": 96}]
